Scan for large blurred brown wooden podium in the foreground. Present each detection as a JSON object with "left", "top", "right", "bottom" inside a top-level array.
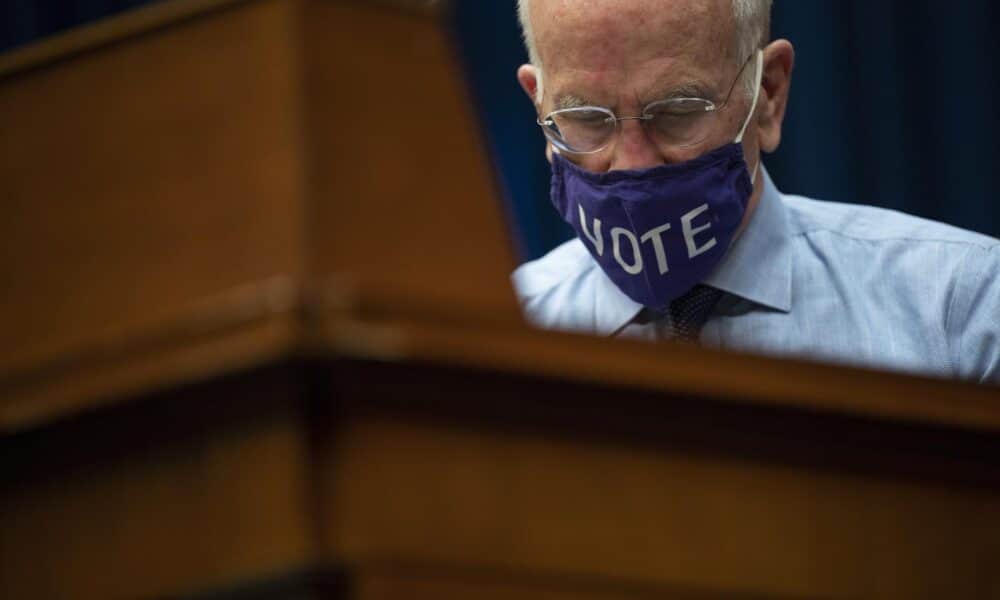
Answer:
[{"left": 0, "top": 0, "right": 1000, "bottom": 600}]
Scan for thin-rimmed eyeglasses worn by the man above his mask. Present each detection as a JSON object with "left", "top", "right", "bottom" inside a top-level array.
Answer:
[{"left": 537, "top": 52, "right": 756, "bottom": 154}]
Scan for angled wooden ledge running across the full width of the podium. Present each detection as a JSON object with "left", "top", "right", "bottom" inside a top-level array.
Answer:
[{"left": 0, "top": 277, "right": 1000, "bottom": 434}]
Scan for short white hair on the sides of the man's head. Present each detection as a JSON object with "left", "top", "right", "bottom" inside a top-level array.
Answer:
[{"left": 517, "top": 0, "right": 772, "bottom": 102}]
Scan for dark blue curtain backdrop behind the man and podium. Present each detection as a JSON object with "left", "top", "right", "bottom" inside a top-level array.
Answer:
[{"left": 7, "top": 0, "right": 1000, "bottom": 259}]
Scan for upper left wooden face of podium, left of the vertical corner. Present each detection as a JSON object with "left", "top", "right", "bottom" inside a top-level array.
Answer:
[{"left": 0, "top": 2, "right": 306, "bottom": 422}]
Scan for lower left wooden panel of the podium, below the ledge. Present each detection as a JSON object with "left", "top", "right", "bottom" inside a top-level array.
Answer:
[{"left": 0, "top": 366, "right": 316, "bottom": 599}]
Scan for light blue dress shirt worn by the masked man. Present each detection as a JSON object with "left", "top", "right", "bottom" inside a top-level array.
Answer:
[{"left": 512, "top": 170, "right": 1000, "bottom": 383}]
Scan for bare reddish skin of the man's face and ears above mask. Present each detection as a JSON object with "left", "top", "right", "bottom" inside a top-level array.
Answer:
[{"left": 517, "top": 0, "right": 794, "bottom": 225}]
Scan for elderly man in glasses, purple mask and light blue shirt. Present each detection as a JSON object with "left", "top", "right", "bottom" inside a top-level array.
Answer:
[{"left": 513, "top": 0, "right": 1000, "bottom": 382}]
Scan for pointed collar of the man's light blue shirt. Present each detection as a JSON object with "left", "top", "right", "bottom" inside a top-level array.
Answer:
[{"left": 590, "top": 165, "right": 792, "bottom": 335}]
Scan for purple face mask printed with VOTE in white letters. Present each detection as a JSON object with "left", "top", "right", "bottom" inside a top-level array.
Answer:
[{"left": 552, "top": 51, "right": 762, "bottom": 310}]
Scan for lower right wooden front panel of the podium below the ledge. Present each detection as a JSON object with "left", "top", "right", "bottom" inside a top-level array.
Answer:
[{"left": 328, "top": 414, "right": 1000, "bottom": 598}]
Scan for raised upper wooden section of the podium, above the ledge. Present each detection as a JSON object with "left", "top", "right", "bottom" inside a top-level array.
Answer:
[{"left": 0, "top": 0, "right": 519, "bottom": 428}]
